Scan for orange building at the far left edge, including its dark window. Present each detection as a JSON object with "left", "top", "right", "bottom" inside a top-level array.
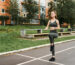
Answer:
[{"left": 0, "top": 0, "right": 11, "bottom": 24}]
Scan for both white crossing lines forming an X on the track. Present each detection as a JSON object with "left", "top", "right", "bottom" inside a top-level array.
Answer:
[{"left": 17, "top": 46, "right": 75, "bottom": 65}]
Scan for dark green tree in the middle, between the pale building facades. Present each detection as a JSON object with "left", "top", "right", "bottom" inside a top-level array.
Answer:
[{"left": 22, "top": 0, "right": 38, "bottom": 19}]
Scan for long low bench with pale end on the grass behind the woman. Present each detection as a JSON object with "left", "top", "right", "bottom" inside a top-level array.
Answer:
[{"left": 20, "top": 29, "right": 71, "bottom": 38}]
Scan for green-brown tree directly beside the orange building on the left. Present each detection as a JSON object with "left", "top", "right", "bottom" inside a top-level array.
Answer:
[{"left": 7, "top": 0, "right": 19, "bottom": 24}]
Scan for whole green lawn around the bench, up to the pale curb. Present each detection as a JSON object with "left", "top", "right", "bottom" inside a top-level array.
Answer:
[{"left": 0, "top": 26, "right": 75, "bottom": 52}]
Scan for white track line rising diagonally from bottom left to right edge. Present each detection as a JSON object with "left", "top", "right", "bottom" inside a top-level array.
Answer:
[{"left": 17, "top": 47, "right": 75, "bottom": 65}]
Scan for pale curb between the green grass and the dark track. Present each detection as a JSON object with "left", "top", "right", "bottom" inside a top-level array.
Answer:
[{"left": 0, "top": 39, "right": 75, "bottom": 55}]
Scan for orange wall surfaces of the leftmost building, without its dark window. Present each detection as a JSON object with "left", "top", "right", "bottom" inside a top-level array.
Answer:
[{"left": 0, "top": 0, "right": 10, "bottom": 24}]
